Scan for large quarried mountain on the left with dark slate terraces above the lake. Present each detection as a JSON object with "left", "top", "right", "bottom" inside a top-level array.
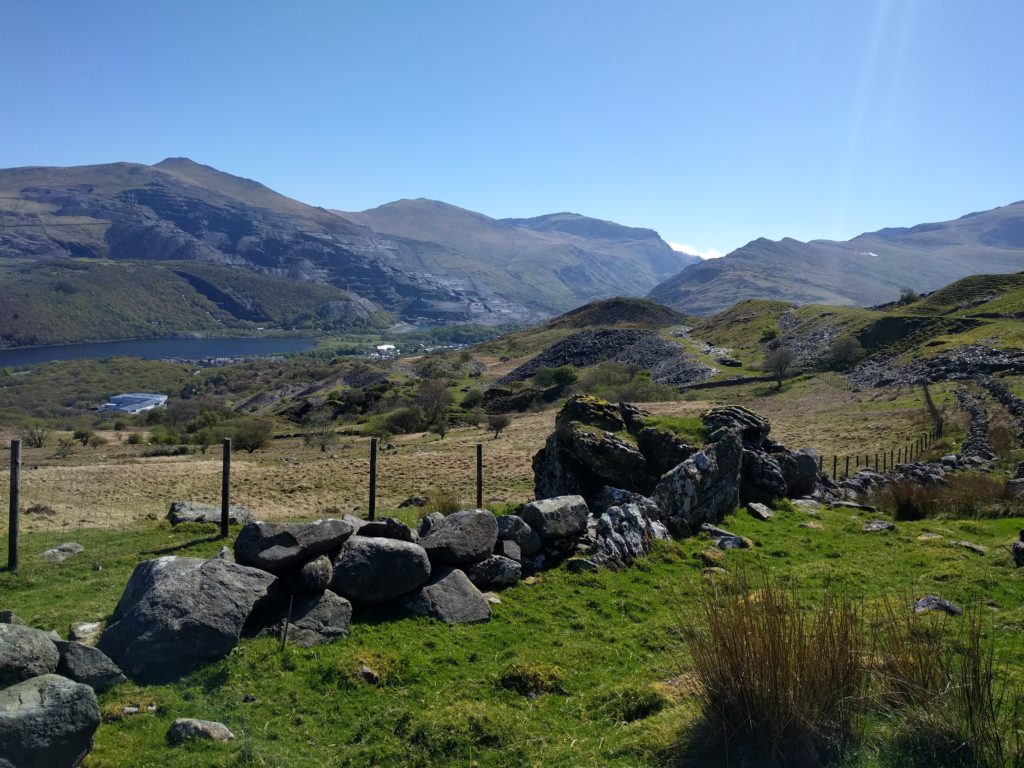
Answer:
[{"left": 0, "top": 158, "right": 535, "bottom": 323}]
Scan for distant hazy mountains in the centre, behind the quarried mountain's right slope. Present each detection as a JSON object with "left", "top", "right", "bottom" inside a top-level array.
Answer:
[{"left": 341, "top": 199, "right": 695, "bottom": 313}]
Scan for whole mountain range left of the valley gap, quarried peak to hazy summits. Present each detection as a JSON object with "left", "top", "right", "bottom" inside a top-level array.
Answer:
[{"left": 0, "top": 158, "right": 694, "bottom": 337}]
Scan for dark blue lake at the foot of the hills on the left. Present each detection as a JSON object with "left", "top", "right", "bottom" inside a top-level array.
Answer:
[{"left": 0, "top": 337, "right": 316, "bottom": 368}]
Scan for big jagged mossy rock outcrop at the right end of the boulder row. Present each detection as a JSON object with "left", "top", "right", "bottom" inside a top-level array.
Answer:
[{"left": 534, "top": 395, "right": 830, "bottom": 536}]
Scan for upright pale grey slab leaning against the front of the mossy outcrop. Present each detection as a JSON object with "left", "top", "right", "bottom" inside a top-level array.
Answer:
[{"left": 652, "top": 431, "right": 742, "bottom": 536}]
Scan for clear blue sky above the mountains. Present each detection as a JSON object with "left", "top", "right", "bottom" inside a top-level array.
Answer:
[{"left": 0, "top": 0, "right": 1024, "bottom": 259}]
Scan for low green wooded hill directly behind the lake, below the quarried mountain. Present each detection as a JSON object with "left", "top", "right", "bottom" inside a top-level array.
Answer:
[{"left": 0, "top": 259, "right": 394, "bottom": 347}]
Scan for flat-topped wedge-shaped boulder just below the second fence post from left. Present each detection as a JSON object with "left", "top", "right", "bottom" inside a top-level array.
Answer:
[{"left": 234, "top": 520, "right": 355, "bottom": 575}]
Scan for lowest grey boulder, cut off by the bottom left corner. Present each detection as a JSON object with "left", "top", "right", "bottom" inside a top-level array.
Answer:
[{"left": 0, "top": 675, "right": 99, "bottom": 768}]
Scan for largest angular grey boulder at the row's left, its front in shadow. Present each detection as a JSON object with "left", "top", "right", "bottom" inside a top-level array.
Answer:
[{"left": 98, "top": 557, "right": 275, "bottom": 682}]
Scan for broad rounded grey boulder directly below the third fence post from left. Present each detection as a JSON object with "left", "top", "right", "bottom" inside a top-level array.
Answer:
[{"left": 330, "top": 536, "right": 430, "bottom": 604}]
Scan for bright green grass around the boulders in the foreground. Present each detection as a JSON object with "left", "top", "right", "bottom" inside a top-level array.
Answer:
[{"left": 0, "top": 504, "right": 1024, "bottom": 768}]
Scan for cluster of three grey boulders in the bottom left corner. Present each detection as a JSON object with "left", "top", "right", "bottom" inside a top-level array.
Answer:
[{"left": 0, "top": 611, "right": 117, "bottom": 768}]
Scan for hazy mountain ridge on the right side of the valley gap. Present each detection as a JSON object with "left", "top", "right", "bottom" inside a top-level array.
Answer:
[{"left": 648, "top": 202, "right": 1024, "bottom": 314}]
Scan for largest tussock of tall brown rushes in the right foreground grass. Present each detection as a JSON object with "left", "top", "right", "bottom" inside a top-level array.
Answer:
[{"left": 690, "top": 575, "right": 865, "bottom": 766}]
